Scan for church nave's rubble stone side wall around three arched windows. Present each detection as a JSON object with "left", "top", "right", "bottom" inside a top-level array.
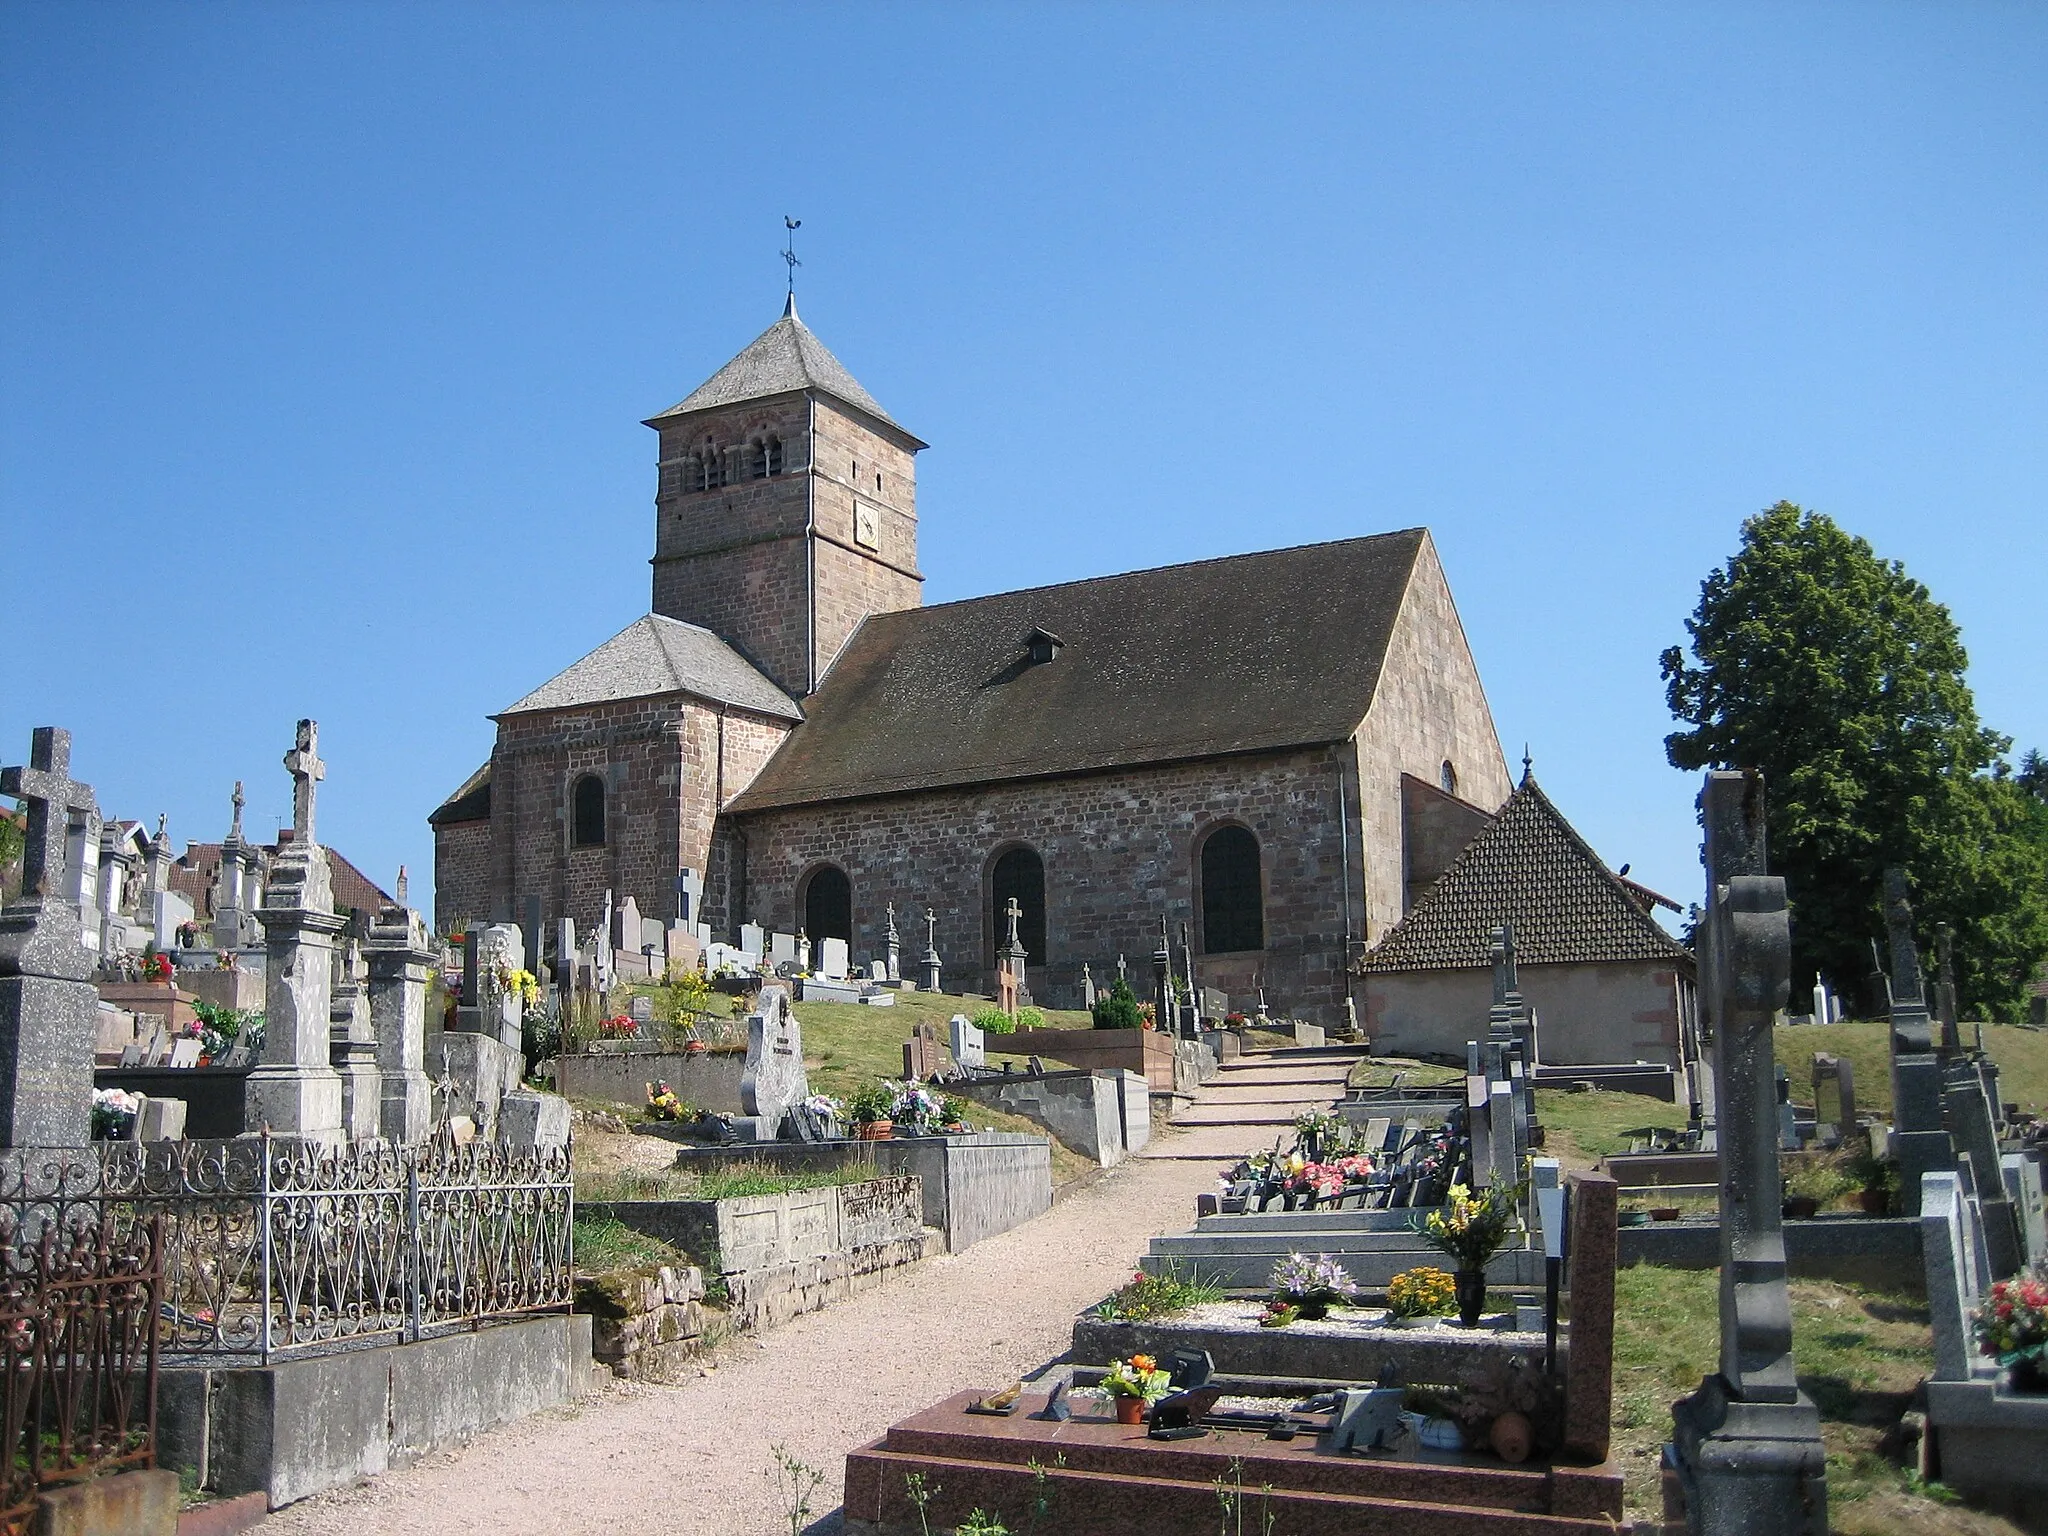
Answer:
[{"left": 719, "top": 748, "right": 1368, "bottom": 1022}]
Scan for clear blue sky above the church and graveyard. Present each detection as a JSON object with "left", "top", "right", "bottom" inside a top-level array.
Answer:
[{"left": 0, "top": 0, "right": 2048, "bottom": 925}]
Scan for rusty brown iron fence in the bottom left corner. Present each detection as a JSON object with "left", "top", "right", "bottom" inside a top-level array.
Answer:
[{"left": 0, "top": 1210, "right": 162, "bottom": 1536}]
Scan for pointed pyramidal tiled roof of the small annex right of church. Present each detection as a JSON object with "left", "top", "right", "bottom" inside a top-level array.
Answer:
[{"left": 1358, "top": 774, "right": 1692, "bottom": 975}]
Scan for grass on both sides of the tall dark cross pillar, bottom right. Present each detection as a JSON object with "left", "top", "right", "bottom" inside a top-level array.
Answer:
[{"left": 1614, "top": 1264, "right": 2017, "bottom": 1536}]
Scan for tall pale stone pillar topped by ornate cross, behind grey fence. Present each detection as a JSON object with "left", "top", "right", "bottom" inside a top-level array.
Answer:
[{"left": 244, "top": 721, "right": 346, "bottom": 1147}]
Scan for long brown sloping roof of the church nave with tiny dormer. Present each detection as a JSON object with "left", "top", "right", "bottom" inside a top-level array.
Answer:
[{"left": 731, "top": 528, "right": 1430, "bottom": 813}]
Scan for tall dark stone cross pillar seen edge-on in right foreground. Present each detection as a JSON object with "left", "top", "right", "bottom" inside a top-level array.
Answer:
[{"left": 1671, "top": 772, "right": 1827, "bottom": 1536}]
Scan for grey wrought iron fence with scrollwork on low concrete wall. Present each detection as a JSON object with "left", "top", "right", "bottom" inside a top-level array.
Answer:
[{"left": 0, "top": 1137, "right": 573, "bottom": 1362}]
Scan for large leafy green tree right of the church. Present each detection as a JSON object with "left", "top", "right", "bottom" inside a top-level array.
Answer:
[{"left": 1661, "top": 502, "right": 2048, "bottom": 1018}]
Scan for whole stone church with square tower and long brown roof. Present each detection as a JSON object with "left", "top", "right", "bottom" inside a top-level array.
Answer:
[{"left": 430, "top": 301, "right": 1513, "bottom": 1024}]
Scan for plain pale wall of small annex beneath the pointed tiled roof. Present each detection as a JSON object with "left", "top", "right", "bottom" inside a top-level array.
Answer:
[{"left": 1360, "top": 961, "right": 1692, "bottom": 1067}]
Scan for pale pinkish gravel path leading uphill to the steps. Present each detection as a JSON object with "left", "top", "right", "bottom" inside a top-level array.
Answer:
[{"left": 264, "top": 1133, "right": 1217, "bottom": 1536}]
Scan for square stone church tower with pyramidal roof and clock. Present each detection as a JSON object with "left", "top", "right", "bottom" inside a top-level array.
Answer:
[{"left": 647, "top": 297, "right": 926, "bottom": 698}]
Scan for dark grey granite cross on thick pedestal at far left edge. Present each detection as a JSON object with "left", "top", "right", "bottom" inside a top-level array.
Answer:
[{"left": 0, "top": 725, "right": 98, "bottom": 1147}]
